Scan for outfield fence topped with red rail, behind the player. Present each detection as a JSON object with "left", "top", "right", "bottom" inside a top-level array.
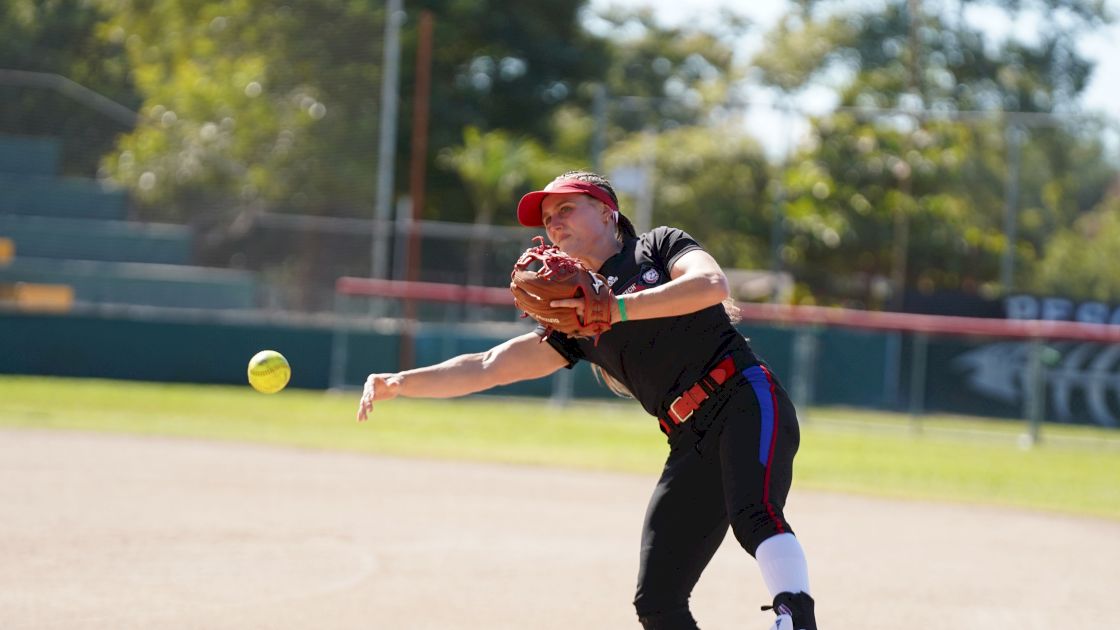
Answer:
[{"left": 330, "top": 278, "right": 1120, "bottom": 442}]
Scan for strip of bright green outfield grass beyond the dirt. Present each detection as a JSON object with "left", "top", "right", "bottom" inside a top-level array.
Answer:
[{"left": 0, "top": 377, "right": 1120, "bottom": 519}]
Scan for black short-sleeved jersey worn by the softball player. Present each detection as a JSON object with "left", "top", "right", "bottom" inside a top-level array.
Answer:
[{"left": 538, "top": 226, "right": 754, "bottom": 417}]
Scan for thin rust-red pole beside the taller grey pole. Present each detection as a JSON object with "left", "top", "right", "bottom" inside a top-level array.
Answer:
[{"left": 400, "top": 10, "right": 432, "bottom": 370}]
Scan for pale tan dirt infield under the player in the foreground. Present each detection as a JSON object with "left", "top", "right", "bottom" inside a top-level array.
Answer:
[{"left": 0, "top": 430, "right": 1120, "bottom": 630}]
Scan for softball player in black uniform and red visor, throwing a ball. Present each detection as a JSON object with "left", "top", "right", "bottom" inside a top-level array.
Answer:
[{"left": 357, "top": 172, "right": 816, "bottom": 630}]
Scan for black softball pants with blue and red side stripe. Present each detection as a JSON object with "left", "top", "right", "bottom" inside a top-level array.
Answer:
[{"left": 634, "top": 365, "right": 801, "bottom": 630}]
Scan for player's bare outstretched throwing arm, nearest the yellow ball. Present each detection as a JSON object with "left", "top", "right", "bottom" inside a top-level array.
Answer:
[{"left": 357, "top": 333, "right": 568, "bottom": 421}]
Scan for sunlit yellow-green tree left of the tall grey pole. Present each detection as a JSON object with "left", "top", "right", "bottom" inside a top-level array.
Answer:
[{"left": 100, "top": 0, "right": 380, "bottom": 221}]
